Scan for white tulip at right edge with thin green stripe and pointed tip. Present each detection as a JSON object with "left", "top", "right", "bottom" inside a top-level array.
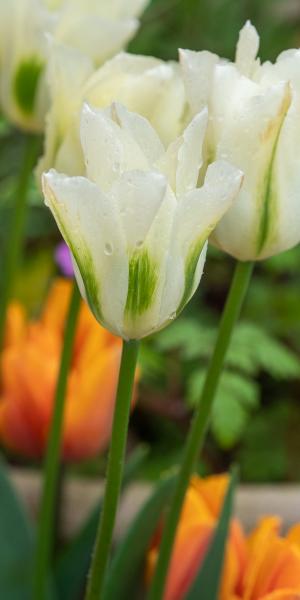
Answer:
[{"left": 181, "top": 22, "right": 300, "bottom": 260}]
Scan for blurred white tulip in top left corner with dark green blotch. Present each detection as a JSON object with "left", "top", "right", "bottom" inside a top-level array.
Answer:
[{"left": 0, "top": 0, "right": 148, "bottom": 132}]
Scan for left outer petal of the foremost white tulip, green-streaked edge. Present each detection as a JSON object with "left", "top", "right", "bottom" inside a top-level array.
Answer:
[{"left": 43, "top": 171, "right": 128, "bottom": 334}]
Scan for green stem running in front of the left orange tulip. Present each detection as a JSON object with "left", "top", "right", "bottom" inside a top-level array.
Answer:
[{"left": 34, "top": 282, "right": 80, "bottom": 600}]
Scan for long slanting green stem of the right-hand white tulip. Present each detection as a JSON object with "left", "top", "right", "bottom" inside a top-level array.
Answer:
[{"left": 148, "top": 262, "right": 253, "bottom": 600}]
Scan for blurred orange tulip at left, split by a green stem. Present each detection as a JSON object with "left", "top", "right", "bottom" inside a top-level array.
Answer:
[{"left": 0, "top": 279, "right": 121, "bottom": 461}]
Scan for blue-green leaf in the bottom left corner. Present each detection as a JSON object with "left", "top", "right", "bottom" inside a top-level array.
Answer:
[{"left": 0, "top": 460, "right": 34, "bottom": 600}]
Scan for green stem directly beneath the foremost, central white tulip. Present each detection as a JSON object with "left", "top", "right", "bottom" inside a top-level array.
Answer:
[{"left": 86, "top": 340, "right": 139, "bottom": 600}]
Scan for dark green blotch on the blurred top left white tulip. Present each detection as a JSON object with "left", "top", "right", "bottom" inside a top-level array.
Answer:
[{"left": 14, "top": 56, "right": 44, "bottom": 115}]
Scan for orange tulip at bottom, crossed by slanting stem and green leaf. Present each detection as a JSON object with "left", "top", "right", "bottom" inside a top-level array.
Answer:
[{"left": 146, "top": 475, "right": 246, "bottom": 600}]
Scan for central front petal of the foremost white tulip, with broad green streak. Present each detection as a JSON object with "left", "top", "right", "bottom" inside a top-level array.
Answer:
[{"left": 111, "top": 171, "right": 176, "bottom": 338}]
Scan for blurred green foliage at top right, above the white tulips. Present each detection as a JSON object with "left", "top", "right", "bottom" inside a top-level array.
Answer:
[{"left": 130, "top": 0, "right": 300, "bottom": 60}]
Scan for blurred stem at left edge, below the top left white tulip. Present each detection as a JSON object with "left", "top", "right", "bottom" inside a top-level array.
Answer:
[{"left": 0, "top": 136, "right": 41, "bottom": 353}]
